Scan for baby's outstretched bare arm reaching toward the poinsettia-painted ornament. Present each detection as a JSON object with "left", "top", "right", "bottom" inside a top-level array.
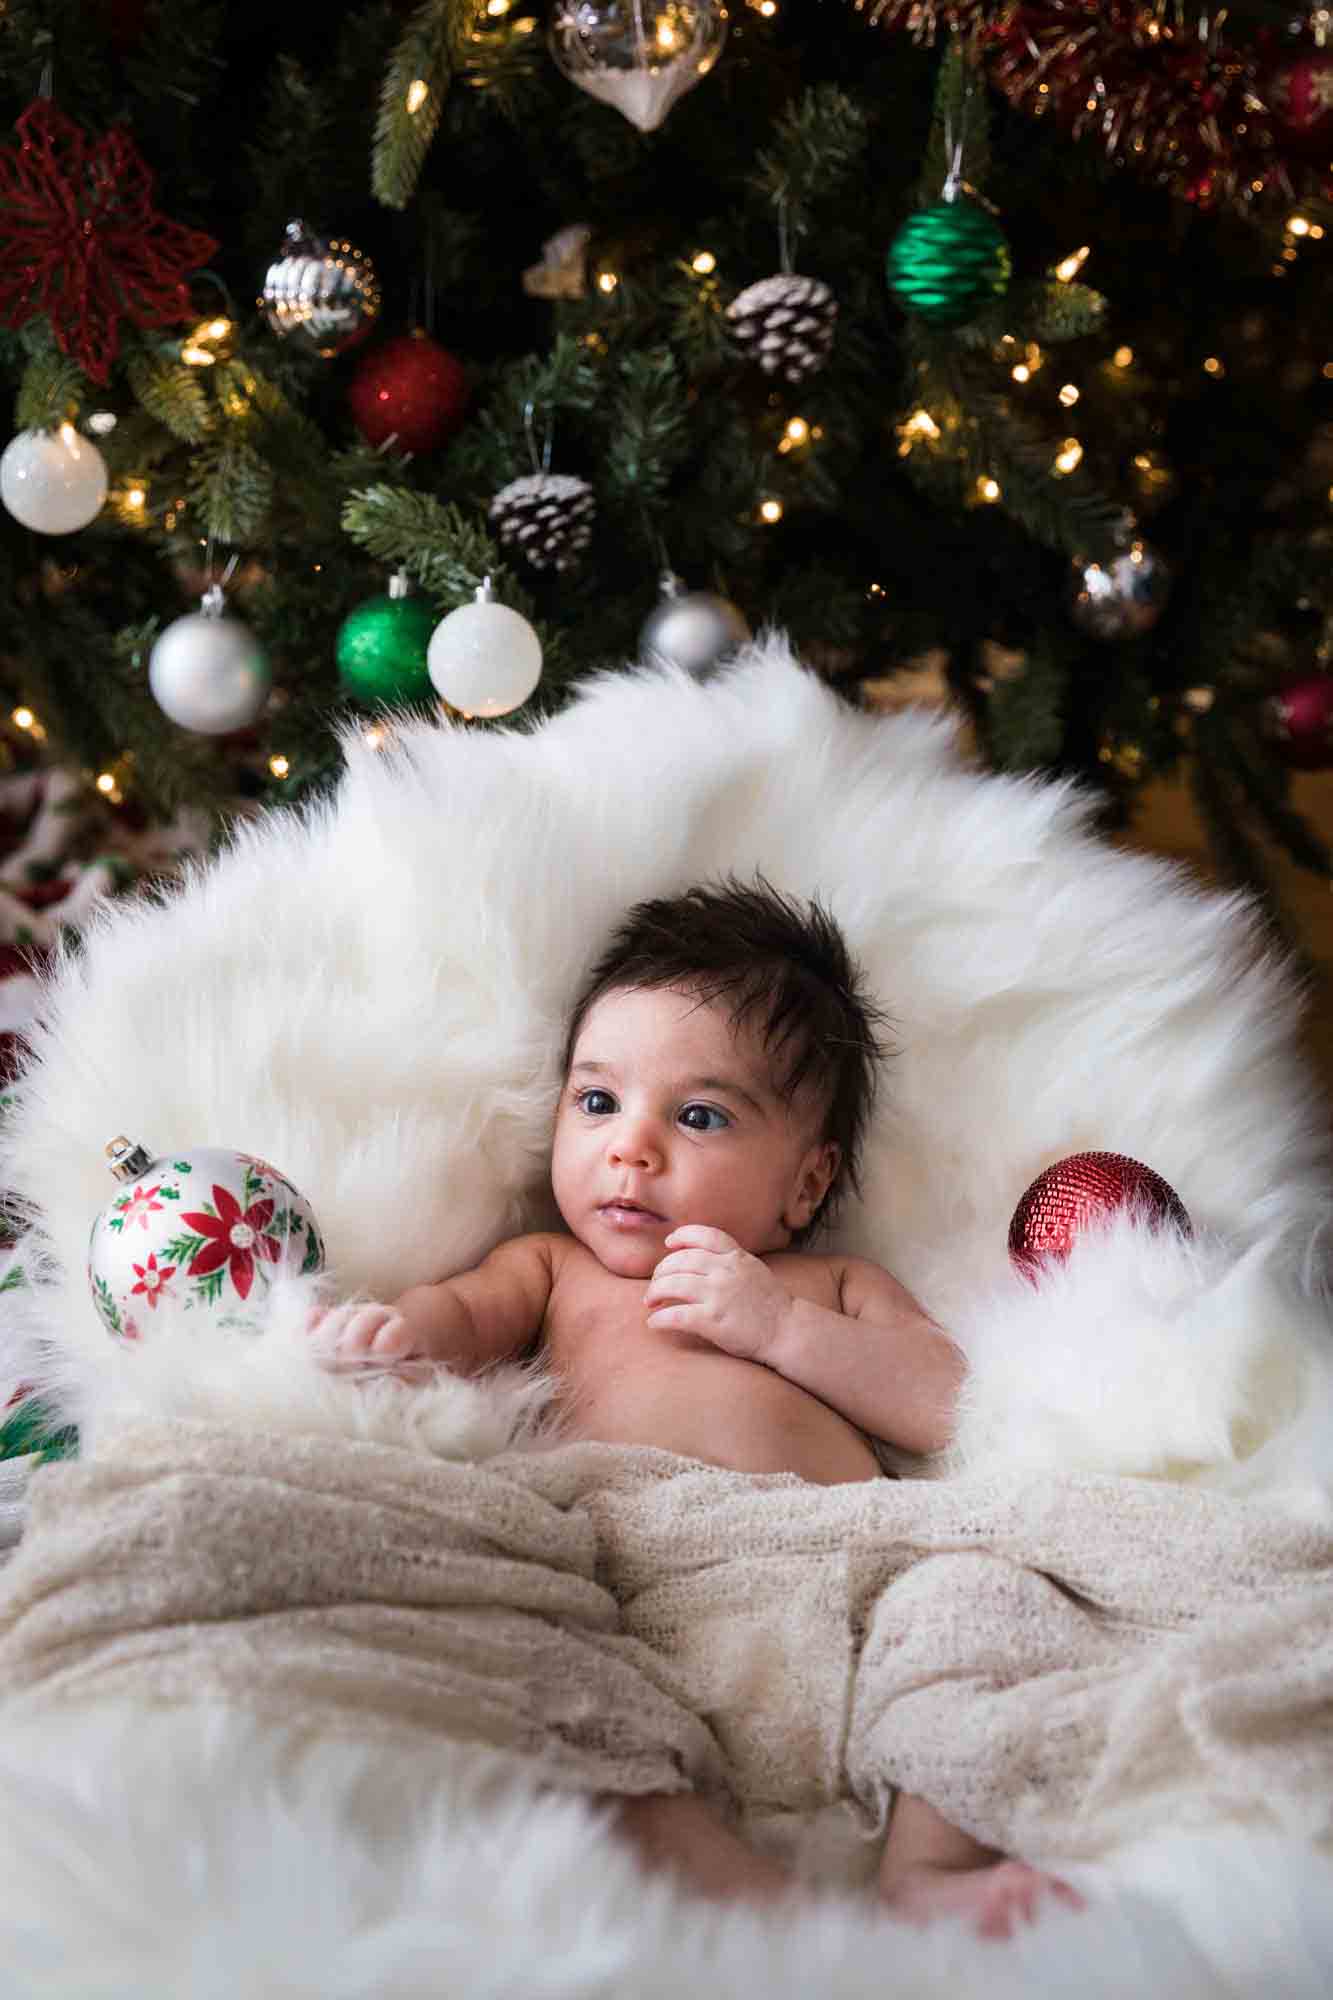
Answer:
[{"left": 316, "top": 1236, "right": 562, "bottom": 1374}]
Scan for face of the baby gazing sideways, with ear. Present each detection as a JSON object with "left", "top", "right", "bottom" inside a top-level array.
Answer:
[{"left": 550, "top": 986, "right": 837, "bottom": 1278}]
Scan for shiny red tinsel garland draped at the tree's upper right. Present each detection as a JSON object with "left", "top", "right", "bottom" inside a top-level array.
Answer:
[{"left": 857, "top": 0, "right": 1329, "bottom": 208}]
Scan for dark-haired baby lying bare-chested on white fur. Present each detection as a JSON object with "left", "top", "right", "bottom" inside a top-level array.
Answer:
[{"left": 318, "top": 880, "right": 1077, "bottom": 1936}]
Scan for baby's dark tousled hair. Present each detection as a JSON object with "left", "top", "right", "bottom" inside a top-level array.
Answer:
[{"left": 564, "top": 874, "right": 889, "bottom": 1244}]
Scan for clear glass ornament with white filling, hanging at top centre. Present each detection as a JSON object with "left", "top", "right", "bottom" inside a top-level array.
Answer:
[{"left": 550, "top": 0, "right": 727, "bottom": 132}]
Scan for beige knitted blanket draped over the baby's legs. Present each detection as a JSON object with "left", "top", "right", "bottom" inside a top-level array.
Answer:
[{"left": 0, "top": 1424, "right": 1333, "bottom": 1860}]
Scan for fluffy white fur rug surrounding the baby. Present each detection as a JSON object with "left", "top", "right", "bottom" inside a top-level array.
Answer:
[{"left": 0, "top": 638, "right": 1333, "bottom": 2000}]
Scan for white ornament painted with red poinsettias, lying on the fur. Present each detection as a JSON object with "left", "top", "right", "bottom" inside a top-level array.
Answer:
[{"left": 88, "top": 1138, "right": 324, "bottom": 1340}]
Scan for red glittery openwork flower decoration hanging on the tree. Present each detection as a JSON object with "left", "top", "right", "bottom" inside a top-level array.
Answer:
[{"left": 0, "top": 98, "right": 218, "bottom": 382}]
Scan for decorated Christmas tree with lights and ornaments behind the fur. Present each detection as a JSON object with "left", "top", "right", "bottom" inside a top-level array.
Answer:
[{"left": 0, "top": 0, "right": 1333, "bottom": 944}]
